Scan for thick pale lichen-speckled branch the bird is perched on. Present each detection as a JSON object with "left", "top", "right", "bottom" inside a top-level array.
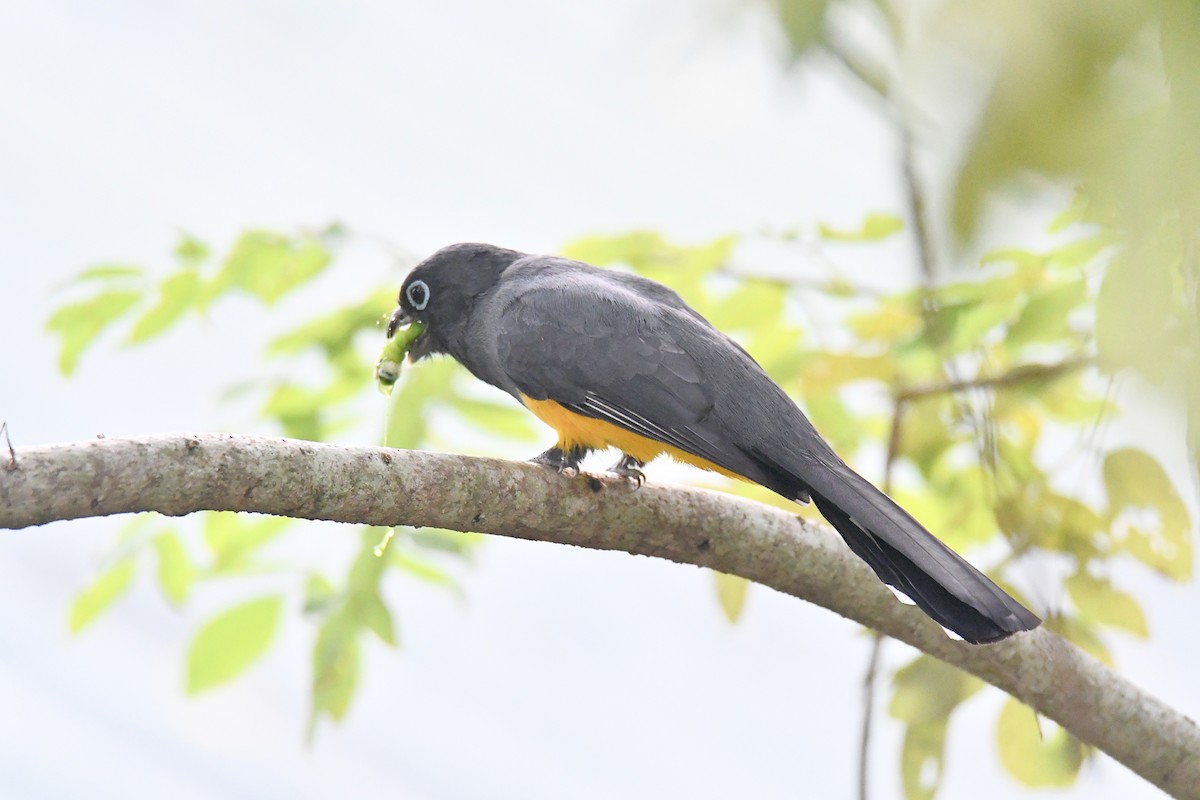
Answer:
[{"left": 0, "top": 434, "right": 1200, "bottom": 799}]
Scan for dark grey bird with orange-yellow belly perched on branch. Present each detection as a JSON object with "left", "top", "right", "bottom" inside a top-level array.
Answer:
[{"left": 388, "top": 243, "right": 1040, "bottom": 644}]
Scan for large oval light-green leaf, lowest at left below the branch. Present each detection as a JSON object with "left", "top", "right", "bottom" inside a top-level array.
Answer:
[{"left": 187, "top": 595, "right": 283, "bottom": 694}]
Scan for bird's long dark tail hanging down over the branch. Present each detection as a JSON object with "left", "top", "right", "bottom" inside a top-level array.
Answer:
[{"left": 760, "top": 450, "right": 1042, "bottom": 644}]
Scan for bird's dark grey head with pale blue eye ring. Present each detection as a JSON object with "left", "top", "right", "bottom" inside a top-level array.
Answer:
[{"left": 388, "top": 242, "right": 524, "bottom": 361}]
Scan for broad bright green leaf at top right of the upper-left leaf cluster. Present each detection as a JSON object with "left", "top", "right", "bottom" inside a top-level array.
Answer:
[{"left": 210, "top": 230, "right": 331, "bottom": 305}]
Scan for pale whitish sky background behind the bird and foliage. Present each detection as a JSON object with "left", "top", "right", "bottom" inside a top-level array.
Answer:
[{"left": 0, "top": 0, "right": 1200, "bottom": 800}]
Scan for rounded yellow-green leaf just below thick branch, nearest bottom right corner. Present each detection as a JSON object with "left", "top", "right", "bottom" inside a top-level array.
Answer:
[{"left": 996, "top": 698, "right": 1085, "bottom": 788}]
